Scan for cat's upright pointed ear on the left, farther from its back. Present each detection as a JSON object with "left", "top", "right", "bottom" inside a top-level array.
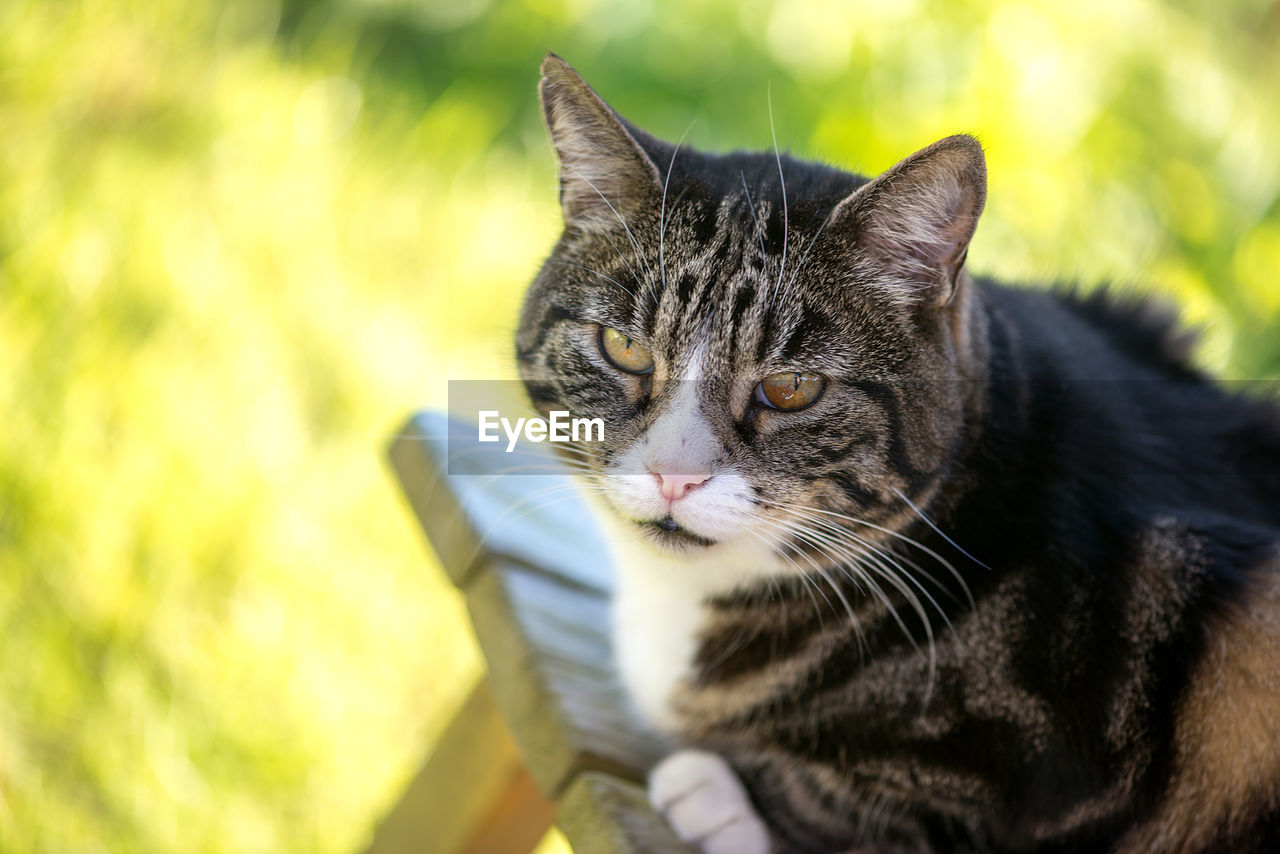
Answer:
[{"left": 538, "top": 54, "right": 660, "bottom": 230}]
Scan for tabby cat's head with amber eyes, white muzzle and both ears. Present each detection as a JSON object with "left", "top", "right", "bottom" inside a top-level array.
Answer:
[{"left": 517, "top": 56, "right": 986, "bottom": 588}]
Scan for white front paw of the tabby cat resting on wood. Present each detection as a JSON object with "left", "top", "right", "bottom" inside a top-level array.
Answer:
[{"left": 649, "top": 750, "right": 769, "bottom": 854}]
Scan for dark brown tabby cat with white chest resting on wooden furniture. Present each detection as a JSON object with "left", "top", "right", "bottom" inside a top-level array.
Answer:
[{"left": 516, "top": 55, "right": 1280, "bottom": 854}]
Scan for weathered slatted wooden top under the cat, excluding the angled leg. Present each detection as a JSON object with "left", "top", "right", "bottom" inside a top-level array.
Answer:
[{"left": 376, "top": 412, "right": 690, "bottom": 854}]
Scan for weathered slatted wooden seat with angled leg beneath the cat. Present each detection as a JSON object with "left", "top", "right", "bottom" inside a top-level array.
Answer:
[{"left": 367, "top": 412, "right": 692, "bottom": 854}]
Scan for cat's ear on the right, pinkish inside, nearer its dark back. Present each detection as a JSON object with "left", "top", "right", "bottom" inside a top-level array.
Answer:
[{"left": 832, "top": 134, "right": 987, "bottom": 305}]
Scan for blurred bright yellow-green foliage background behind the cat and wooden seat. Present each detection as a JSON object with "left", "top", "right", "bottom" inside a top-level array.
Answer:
[{"left": 0, "top": 0, "right": 1280, "bottom": 853}]
